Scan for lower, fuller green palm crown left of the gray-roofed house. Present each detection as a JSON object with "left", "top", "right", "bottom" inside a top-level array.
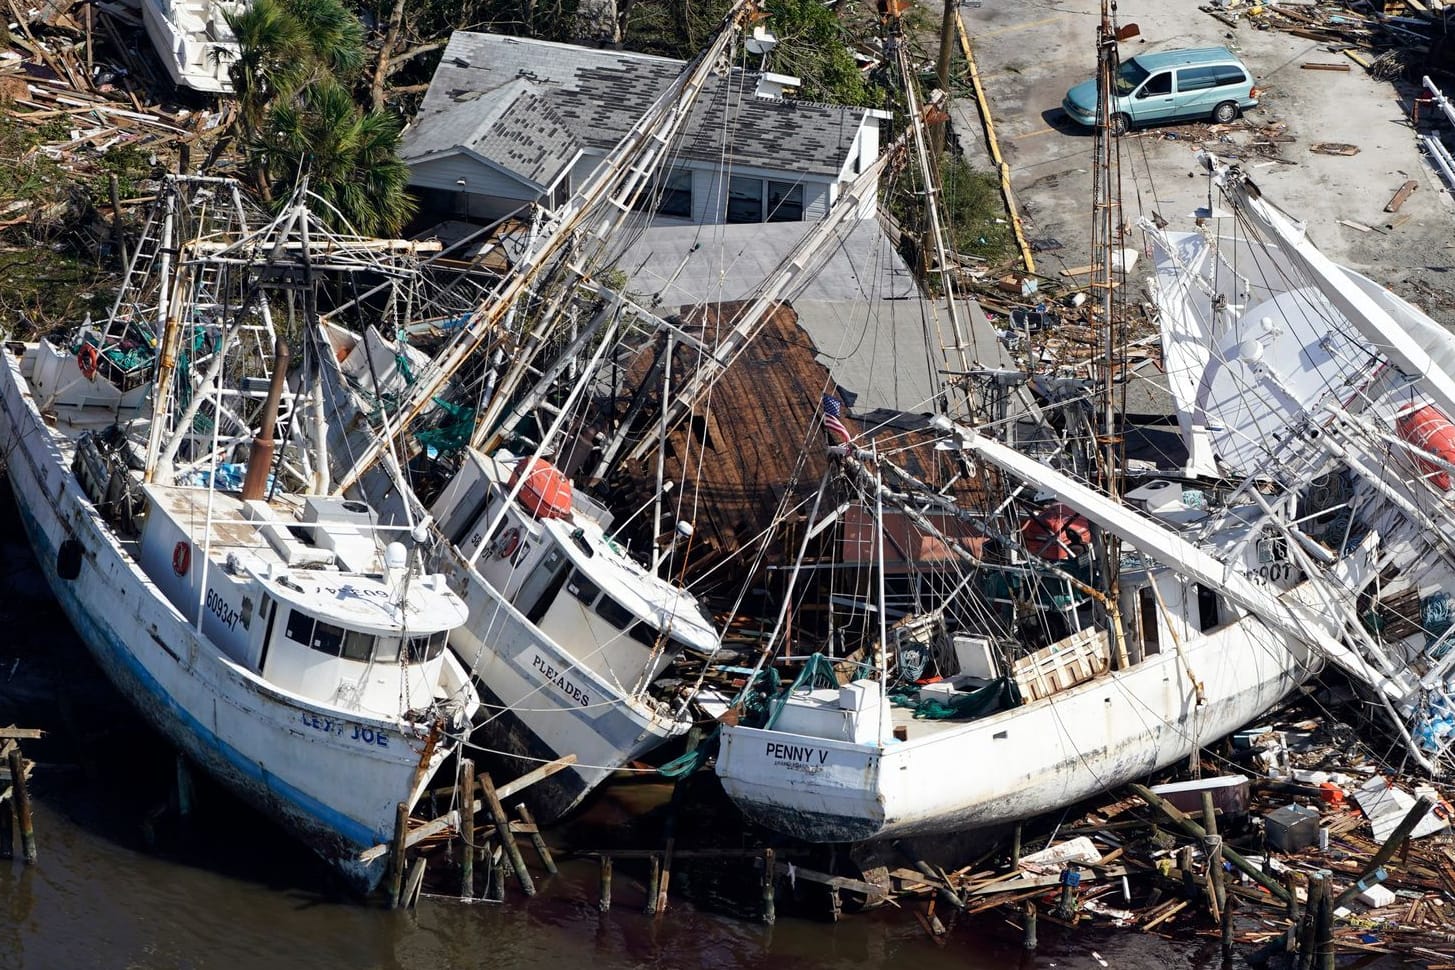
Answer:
[{"left": 253, "top": 77, "right": 415, "bottom": 236}]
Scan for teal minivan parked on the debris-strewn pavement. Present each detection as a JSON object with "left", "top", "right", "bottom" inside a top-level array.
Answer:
[{"left": 1061, "top": 47, "right": 1259, "bottom": 135}]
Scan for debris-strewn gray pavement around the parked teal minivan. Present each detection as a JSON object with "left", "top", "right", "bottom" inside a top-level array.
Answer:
[{"left": 953, "top": 0, "right": 1455, "bottom": 312}]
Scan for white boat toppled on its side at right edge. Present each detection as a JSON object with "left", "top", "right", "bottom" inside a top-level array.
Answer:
[{"left": 1144, "top": 154, "right": 1455, "bottom": 777}]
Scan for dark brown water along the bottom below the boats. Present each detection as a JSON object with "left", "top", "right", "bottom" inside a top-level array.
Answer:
[{"left": 0, "top": 492, "right": 1218, "bottom": 970}]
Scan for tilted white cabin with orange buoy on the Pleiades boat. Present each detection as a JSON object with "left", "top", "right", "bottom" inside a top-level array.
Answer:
[{"left": 432, "top": 449, "right": 720, "bottom": 688}]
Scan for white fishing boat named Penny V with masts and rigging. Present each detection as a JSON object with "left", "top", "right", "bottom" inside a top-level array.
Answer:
[{"left": 716, "top": 4, "right": 1340, "bottom": 842}]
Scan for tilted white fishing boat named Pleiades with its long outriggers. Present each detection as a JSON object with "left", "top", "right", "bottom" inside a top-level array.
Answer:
[{"left": 322, "top": 1, "right": 902, "bottom": 822}]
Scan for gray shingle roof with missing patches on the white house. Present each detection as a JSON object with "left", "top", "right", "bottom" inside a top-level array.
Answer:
[{"left": 403, "top": 31, "right": 866, "bottom": 177}]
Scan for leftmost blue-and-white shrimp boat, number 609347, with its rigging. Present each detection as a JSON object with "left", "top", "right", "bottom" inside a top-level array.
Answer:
[{"left": 0, "top": 176, "right": 479, "bottom": 891}]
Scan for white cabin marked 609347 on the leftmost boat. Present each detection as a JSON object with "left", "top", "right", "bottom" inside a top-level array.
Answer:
[{"left": 140, "top": 486, "right": 466, "bottom": 714}]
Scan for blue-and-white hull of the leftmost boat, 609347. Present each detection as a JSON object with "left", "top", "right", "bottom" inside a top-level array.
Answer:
[{"left": 0, "top": 350, "right": 445, "bottom": 890}]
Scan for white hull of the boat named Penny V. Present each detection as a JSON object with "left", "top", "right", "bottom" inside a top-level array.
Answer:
[{"left": 717, "top": 618, "right": 1314, "bottom": 842}]
